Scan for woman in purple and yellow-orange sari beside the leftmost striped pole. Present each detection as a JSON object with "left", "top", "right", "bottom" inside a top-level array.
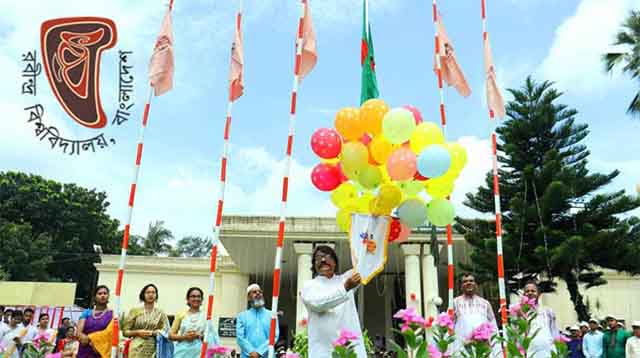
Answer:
[{"left": 77, "top": 285, "right": 113, "bottom": 358}]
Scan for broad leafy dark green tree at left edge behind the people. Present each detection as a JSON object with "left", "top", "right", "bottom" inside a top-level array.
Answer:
[{"left": 0, "top": 172, "right": 121, "bottom": 303}]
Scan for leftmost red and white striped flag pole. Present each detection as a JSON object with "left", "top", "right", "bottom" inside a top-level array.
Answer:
[{"left": 111, "top": 85, "right": 153, "bottom": 358}]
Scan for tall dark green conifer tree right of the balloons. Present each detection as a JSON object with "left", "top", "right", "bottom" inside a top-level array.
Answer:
[{"left": 456, "top": 78, "right": 640, "bottom": 320}]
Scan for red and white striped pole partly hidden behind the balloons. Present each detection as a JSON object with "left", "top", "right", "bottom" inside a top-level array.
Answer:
[{"left": 433, "top": 0, "right": 454, "bottom": 314}]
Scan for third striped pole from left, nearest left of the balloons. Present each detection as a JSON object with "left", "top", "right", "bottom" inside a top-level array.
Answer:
[{"left": 269, "top": 0, "right": 308, "bottom": 358}]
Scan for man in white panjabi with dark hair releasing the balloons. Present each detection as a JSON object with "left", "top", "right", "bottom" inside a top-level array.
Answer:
[{"left": 300, "top": 245, "right": 367, "bottom": 358}]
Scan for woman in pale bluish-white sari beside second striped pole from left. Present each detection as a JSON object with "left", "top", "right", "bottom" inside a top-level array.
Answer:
[{"left": 169, "top": 287, "right": 218, "bottom": 358}]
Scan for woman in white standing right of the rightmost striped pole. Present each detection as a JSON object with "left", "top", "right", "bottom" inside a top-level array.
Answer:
[{"left": 524, "top": 282, "right": 560, "bottom": 358}]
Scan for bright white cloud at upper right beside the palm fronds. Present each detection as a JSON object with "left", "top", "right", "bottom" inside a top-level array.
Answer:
[{"left": 539, "top": 0, "right": 637, "bottom": 94}]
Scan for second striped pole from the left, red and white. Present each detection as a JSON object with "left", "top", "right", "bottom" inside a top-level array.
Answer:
[{"left": 200, "top": 0, "right": 243, "bottom": 358}]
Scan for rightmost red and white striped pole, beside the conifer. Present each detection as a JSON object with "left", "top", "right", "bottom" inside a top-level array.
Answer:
[{"left": 480, "top": 0, "right": 508, "bottom": 350}]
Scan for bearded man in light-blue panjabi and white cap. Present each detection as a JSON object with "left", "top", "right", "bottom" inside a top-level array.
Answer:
[{"left": 236, "top": 283, "right": 280, "bottom": 358}]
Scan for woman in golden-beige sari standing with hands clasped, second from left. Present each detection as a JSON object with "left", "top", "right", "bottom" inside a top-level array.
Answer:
[{"left": 122, "top": 283, "right": 169, "bottom": 358}]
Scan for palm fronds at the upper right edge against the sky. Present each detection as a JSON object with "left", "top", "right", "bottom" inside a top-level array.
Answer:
[{"left": 602, "top": 10, "right": 640, "bottom": 116}]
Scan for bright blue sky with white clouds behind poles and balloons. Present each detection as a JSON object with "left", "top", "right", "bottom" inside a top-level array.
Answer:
[{"left": 0, "top": 0, "right": 640, "bottom": 242}]
